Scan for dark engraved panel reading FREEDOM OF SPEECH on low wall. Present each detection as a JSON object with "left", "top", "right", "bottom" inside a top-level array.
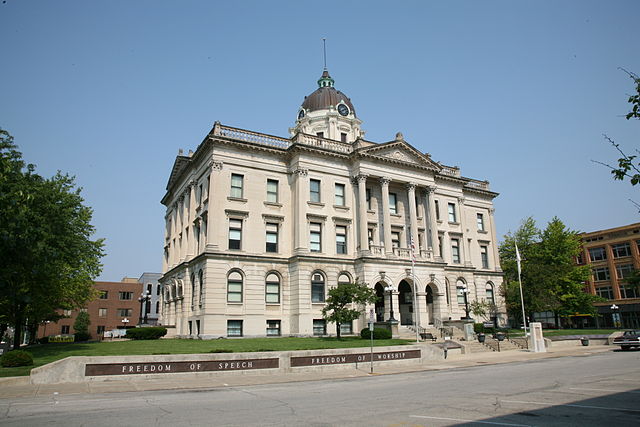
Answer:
[{"left": 84, "top": 358, "right": 280, "bottom": 376}]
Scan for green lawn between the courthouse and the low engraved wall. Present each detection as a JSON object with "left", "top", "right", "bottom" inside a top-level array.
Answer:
[{"left": 0, "top": 337, "right": 412, "bottom": 377}]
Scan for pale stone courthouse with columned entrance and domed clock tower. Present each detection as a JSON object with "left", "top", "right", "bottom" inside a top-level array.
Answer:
[{"left": 160, "top": 70, "right": 506, "bottom": 339}]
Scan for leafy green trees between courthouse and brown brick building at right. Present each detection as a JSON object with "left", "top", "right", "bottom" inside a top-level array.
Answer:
[{"left": 500, "top": 217, "right": 601, "bottom": 328}]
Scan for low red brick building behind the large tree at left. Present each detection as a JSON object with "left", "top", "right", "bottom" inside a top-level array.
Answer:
[{"left": 38, "top": 277, "right": 143, "bottom": 339}]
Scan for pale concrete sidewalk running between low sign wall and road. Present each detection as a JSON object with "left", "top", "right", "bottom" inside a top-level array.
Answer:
[{"left": 0, "top": 343, "right": 617, "bottom": 399}]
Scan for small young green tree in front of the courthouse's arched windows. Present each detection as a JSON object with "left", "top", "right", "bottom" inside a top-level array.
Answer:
[{"left": 322, "top": 279, "right": 378, "bottom": 338}]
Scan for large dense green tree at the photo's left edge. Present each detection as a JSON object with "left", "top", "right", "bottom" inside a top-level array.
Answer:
[{"left": 0, "top": 129, "right": 104, "bottom": 348}]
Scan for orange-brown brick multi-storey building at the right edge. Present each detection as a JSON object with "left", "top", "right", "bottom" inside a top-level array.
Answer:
[{"left": 578, "top": 223, "right": 640, "bottom": 328}]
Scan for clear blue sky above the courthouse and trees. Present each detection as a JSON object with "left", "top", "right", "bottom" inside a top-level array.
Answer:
[{"left": 0, "top": 0, "right": 640, "bottom": 280}]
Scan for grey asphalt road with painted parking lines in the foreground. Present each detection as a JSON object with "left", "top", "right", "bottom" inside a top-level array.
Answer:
[{"left": 0, "top": 351, "right": 640, "bottom": 427}]
